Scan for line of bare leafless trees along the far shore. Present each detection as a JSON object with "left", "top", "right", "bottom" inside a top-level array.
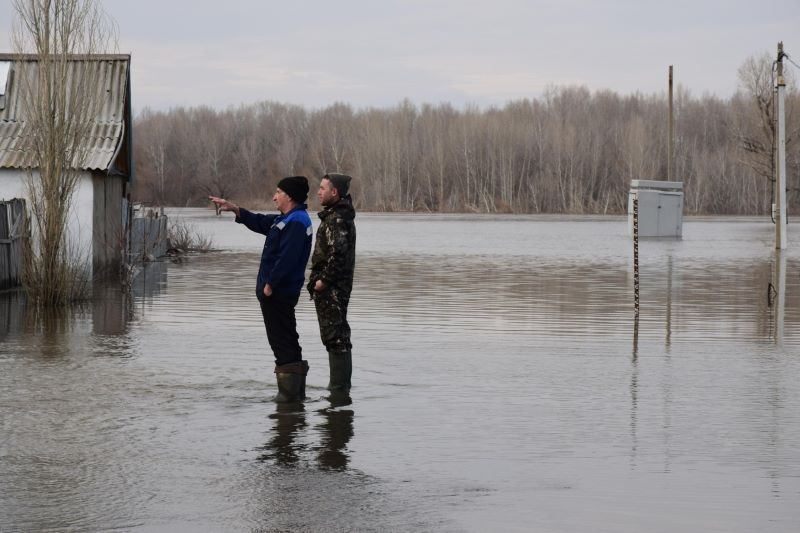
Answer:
[{"left": 134, "top": 54, "right": 800, "bottom": 215}]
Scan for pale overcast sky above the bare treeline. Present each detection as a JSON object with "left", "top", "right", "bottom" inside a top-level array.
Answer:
[{"left": 0, "top": 0, "right": 800, "bottom": 110}]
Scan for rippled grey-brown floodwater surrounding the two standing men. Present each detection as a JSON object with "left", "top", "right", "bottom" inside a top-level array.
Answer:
[{"left": 0, "top": 209, "right": 800, "bottom": 532}]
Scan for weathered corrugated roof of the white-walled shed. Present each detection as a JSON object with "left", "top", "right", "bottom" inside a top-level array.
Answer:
[{"left": 0, "top": 54, "right": 130, "bottom": 170}]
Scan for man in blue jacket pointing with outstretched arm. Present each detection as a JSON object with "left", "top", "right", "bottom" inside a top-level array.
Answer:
[{"left": 209, "top": 176, "right": 312, "bottom": 401}]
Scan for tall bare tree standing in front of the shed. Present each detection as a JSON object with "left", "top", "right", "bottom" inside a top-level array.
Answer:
[{"left": 12, "top": 0, "right": 115, "bottom": 305}]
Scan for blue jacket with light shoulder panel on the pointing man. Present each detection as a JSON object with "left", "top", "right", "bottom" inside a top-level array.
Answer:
[{"left": 236, "top": 204, "right": 313, "bottom": 297}]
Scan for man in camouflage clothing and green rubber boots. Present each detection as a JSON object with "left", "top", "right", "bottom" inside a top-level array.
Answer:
[{"left": 308, "top": 174, "right": 356, "bottom": 396}]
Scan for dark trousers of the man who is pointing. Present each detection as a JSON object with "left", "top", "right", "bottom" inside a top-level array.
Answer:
[{"left": 258, "top": 293, "right": 303, "bottom": 365}]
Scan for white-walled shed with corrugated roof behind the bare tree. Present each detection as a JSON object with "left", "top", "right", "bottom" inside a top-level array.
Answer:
[{"left": 0, "top": 54, "right": 133, "bottom": 274}]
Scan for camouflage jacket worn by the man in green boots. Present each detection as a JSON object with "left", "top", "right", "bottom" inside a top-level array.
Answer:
[{"left": 308, "top": 195, "right": 356, "bottom": 295}]
